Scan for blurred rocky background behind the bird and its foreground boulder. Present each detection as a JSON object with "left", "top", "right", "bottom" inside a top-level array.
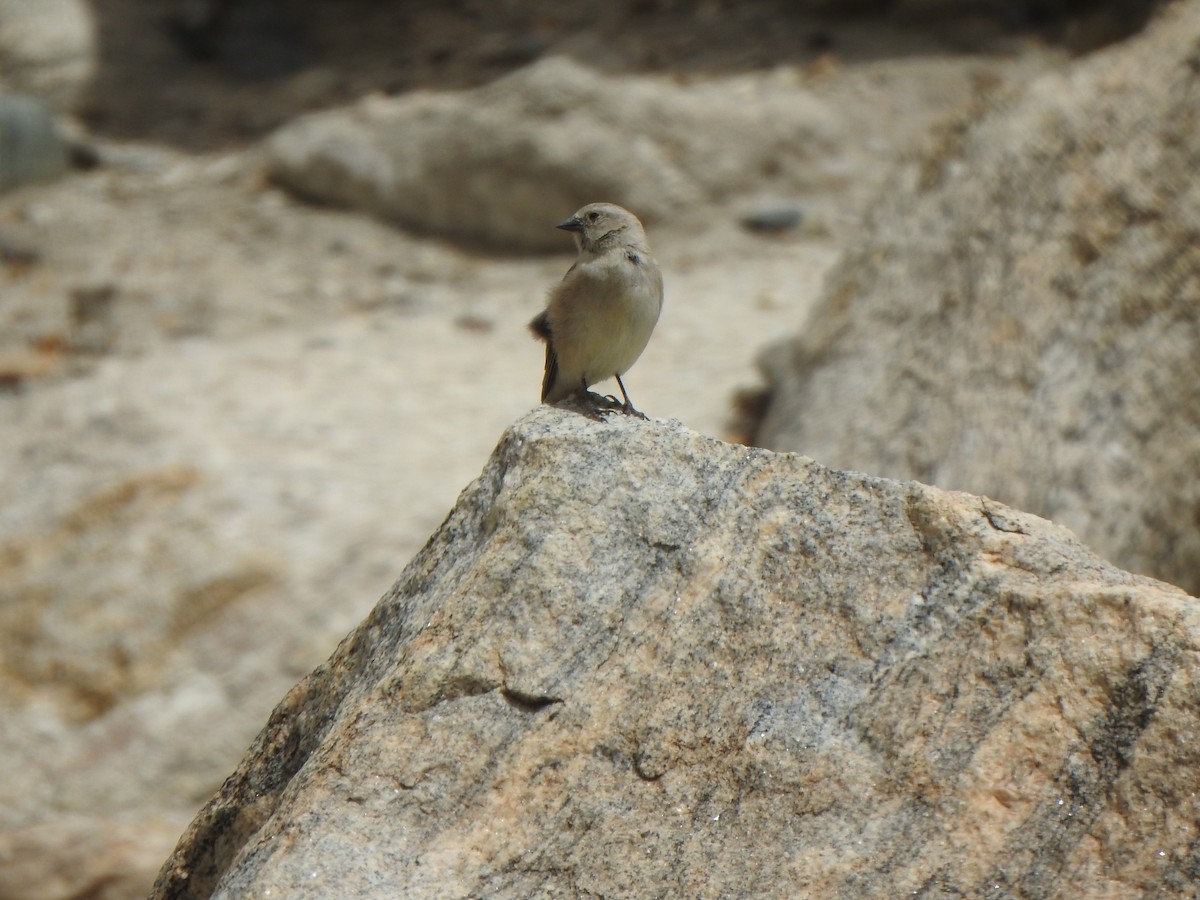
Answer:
[{"left": 0, "top": 0, "right": 1200, "bottom": 898}]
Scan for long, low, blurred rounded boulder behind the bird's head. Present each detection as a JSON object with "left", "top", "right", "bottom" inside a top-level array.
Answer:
[{"left": 269, "top": 58, "right": 838, "bottom": 251}]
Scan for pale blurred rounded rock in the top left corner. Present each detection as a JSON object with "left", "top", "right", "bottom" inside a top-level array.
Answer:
[{"left": 0, "top": 0, "right": 96, "bottom": 108}]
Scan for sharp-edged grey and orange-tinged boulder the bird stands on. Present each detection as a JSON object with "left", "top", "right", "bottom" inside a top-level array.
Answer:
[{"left": 154, "top": 408, "right": 1200, "bottom": 898}]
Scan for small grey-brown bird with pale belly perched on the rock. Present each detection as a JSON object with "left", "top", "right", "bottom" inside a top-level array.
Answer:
[{"left": 529, "top": 203, "right": 662, "bottom": 419}]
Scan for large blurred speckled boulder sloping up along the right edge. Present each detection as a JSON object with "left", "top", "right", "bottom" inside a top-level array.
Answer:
[{"left": 758, "top": 2, "right": 1200, "bottom": 600}]
